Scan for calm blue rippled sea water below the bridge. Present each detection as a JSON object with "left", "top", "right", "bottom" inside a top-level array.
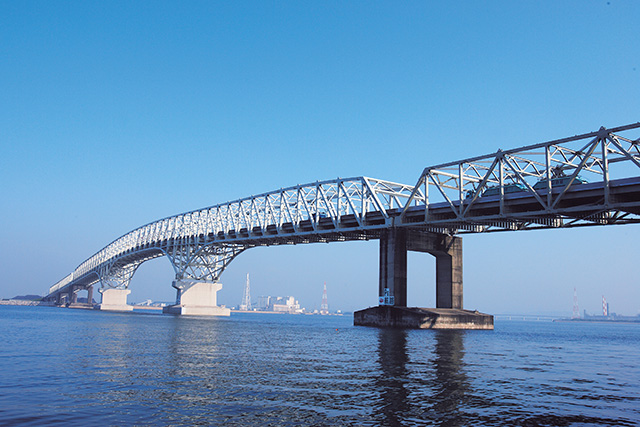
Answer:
[{"left": 0, "top": 306, "right": 640, "bottom": 426}]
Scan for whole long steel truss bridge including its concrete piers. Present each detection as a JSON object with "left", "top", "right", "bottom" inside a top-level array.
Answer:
[{"left": 45, "top": 123, "right": 640, "bottom": 327}]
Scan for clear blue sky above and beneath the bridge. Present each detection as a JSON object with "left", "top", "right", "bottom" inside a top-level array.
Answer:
[{"left": 0, "top": 0, "right": 640, "bottom": 315}]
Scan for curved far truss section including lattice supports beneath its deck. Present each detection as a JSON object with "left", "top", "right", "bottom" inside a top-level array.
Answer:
[{"left": 49, "top": 177, "right": 423, "bottom": 296}]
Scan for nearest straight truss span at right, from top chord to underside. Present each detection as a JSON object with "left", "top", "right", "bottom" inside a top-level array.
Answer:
[{"left": 401, "top": 123, "right": 640, "bottom": 229}]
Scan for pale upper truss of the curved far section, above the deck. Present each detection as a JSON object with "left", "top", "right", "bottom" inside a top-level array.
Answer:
[{"left": 67, "top": 177, "right": 425, "bottom": 286}]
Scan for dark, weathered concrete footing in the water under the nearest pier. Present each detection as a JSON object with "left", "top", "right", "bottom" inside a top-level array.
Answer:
[{"left": 353, "top": 305, "right": 493, "bottom": 329}]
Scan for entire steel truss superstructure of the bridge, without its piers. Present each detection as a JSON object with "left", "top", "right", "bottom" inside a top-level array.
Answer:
[{"left": 50, "top": 123, "right": 640, "bottom": 300}]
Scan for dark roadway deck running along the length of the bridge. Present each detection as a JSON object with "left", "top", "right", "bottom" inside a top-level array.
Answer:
[{"left": 48, "top": 177, "right": 640, "bottom": 300}]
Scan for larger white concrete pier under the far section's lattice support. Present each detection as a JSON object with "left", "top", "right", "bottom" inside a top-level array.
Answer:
[{"left": 162, "top": 279, "right": 231, "bottom": 316}]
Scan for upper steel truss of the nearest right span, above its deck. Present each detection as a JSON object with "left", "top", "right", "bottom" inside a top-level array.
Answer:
[{"left": 402, "top": 123, "right": 640, "bottom": 231}]
